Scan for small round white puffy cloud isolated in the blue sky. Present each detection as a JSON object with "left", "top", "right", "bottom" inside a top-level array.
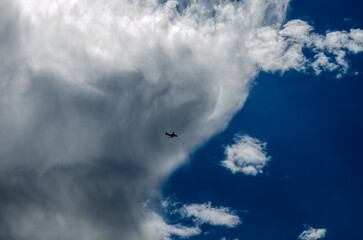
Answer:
[{"left": 221, "top": 135, "right": 270, "bottom": 176}]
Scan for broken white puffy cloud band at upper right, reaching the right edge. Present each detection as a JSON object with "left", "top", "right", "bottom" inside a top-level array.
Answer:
[{"left": 246, "top": 19, "right": 363, "bottom": 77}]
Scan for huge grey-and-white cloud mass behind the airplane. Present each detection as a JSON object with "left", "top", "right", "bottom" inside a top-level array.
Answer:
[{"left": 0, "top": 0, "right": 361, "bottom": 240}]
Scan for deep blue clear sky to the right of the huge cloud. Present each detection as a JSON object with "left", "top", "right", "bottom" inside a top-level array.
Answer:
[{"left": 163, "top": 0, "right": 363, "bottom": 240}]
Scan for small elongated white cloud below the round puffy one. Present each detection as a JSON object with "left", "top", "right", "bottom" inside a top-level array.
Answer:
[{"left": 179, "top": 202, "right": 241, "bottom": 227}]
